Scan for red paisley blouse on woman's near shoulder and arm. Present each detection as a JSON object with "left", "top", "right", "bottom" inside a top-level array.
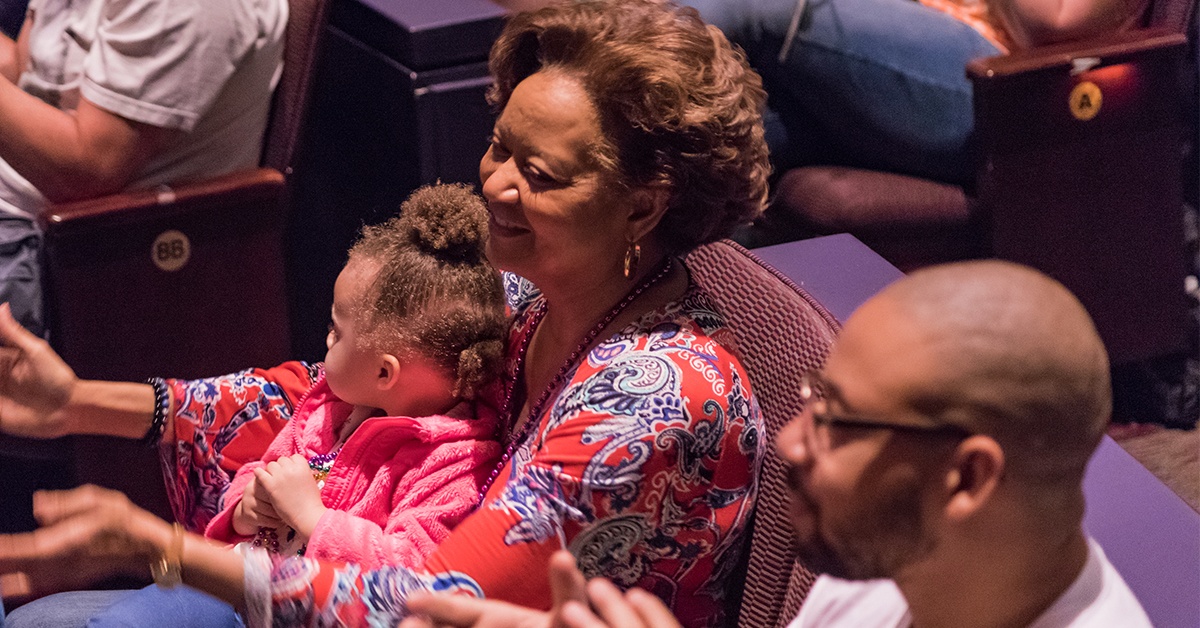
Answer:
[{"left": 246, "top": 288, "right": 763, "bottom": 626}]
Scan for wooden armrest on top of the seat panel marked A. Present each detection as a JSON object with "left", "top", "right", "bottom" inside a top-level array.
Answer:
[{"left": 967, "top": 29, "right": 1187, "bottom": 79}]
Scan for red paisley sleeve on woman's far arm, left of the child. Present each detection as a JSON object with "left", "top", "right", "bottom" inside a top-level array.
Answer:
[{"left": 160, "top": 361, "right": 322, "bottom": 534}]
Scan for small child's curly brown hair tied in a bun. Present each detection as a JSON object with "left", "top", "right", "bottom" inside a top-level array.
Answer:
[{"left": 348, "top": 185, "right": 508, "bottom": 399}]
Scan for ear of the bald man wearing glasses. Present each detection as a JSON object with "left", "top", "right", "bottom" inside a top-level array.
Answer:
[{"left": 943, "top": 435, "right": 1006, "bottom": 522}]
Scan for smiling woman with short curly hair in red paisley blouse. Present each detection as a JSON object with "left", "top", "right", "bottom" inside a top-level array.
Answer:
[{"left": 0, "top": 0, "right": 768, "bottom": 626}]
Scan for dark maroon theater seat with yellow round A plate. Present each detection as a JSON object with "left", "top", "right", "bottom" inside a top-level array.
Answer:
[{"left": 768, "top": 0, "right": 1200, "bottom": 403}]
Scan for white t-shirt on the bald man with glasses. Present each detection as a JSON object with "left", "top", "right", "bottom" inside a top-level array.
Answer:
[{"left": 788, "top": 539, "right": 1151, "bottom": 628}]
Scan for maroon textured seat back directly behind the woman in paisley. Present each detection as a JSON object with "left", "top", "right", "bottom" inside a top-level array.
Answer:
[{"left": 686, "top": 240, "right": 839, "bottom": 628}]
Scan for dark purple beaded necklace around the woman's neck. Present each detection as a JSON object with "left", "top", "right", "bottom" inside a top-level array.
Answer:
[{"left": 479, "top": 257, "right": 674, "bottom": 503}]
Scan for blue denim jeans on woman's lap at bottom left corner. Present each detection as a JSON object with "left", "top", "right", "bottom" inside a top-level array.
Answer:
[{"left": 6, "top": 585, "right": 242, "bottom": 628}]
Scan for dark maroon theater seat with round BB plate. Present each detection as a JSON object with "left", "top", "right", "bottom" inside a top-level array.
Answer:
[{"left": 23, "top": 0, "right": 329, "bottom": 519}]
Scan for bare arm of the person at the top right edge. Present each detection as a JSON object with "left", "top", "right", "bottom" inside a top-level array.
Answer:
[{"left": 991, "top": 0, "right": 1134, "bottom": 48}]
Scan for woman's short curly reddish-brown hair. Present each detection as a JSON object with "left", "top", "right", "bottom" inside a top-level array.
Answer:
[{"left": 487, "top": 0, "right": 770, "bottom": 253}]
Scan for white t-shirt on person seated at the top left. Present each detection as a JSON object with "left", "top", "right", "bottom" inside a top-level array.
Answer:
[{"left": 0, "top": 0, "right": 288, "bottom": 219}]
